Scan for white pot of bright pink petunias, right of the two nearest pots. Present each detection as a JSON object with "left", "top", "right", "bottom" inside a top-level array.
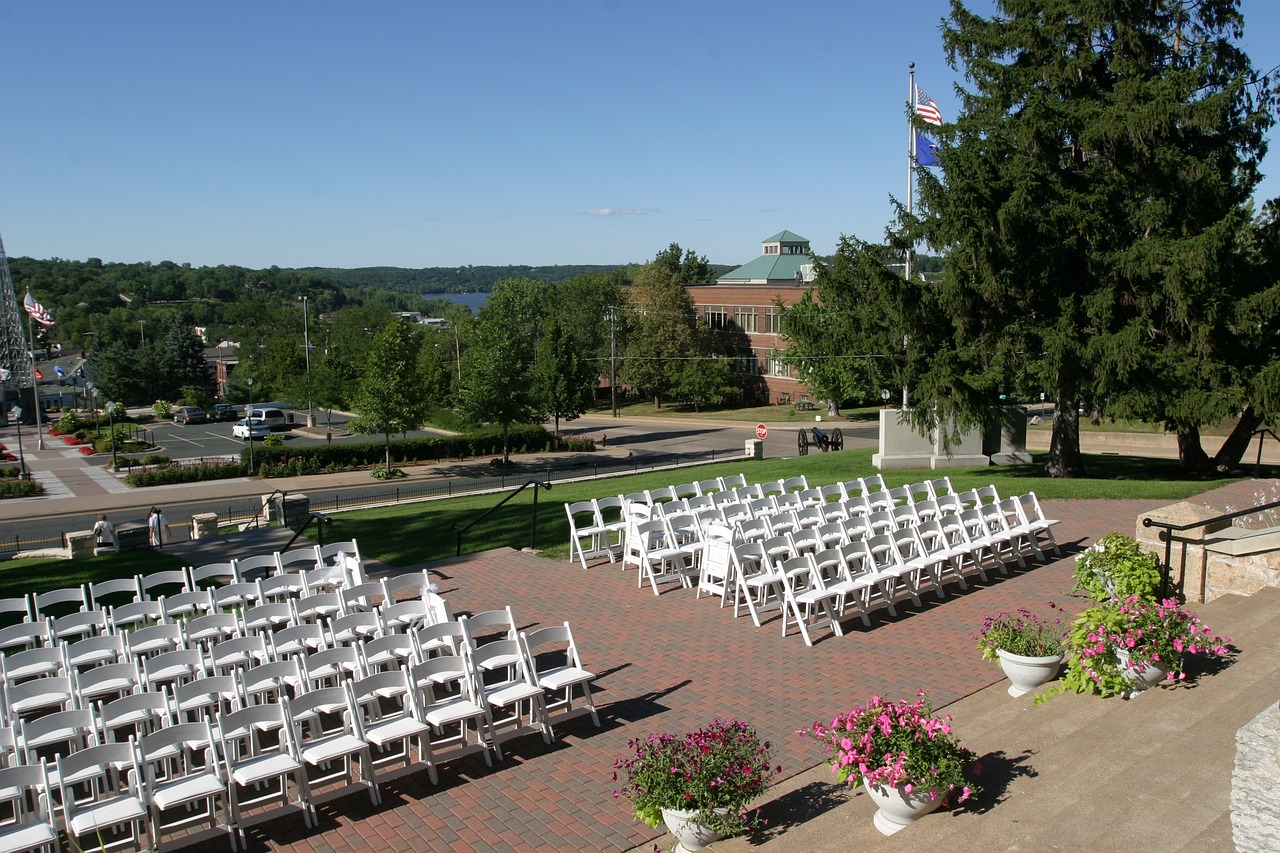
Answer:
[{"left": 800, "top": 692, "right": 979, "bottom": 835}]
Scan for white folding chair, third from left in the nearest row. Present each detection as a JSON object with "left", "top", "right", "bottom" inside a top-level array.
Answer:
[{"left": 138, "top": 720, "right": 239, "bottom": 850}]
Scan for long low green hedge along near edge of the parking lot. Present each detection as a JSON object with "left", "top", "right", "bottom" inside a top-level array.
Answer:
[{"left": 241, "top": 424, "right": 553, "bottom": 476}]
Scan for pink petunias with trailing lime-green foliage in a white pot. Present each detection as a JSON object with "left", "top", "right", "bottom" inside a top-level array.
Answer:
[{"left": 1062, "top": 596, "right": 1231, "bottom": 697}]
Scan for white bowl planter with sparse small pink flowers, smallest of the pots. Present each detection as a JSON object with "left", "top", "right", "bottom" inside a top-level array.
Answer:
[{"left": 974, "top": 602, "right": 1066, "bottom": 697}]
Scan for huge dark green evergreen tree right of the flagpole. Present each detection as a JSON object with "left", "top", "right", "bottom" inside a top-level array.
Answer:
[{"left": 902, "top": 0, "right": 1275, "bottom": 476}]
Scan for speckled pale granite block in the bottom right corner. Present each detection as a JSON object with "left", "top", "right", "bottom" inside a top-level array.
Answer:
[{"left": 1231, "top": 702, "right": 1280, "bottom": 853}]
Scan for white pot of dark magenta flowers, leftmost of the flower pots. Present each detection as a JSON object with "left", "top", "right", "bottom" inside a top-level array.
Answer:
[{"left": 613, "top": 720, "right": 782, "bottom": 850}]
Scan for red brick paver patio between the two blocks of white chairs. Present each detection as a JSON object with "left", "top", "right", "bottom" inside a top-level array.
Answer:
[{"left": 197, "top": 492, "right": 1218, "bottom": 853}]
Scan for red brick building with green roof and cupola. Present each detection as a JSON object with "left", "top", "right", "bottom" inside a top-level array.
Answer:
[{"left": 685, "top": 231, "right": 815, "bottom": 405}]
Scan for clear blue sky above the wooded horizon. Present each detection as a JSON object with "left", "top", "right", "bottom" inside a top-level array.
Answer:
[{"left": 0, "top": 0, "right": 1280, "bottom": 268}]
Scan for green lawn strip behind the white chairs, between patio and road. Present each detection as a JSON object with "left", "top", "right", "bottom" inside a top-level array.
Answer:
[{"left": 0, "top": 448, "right": 1236, "bottom": 597}]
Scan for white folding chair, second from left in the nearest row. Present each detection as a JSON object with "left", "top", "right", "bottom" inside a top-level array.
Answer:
[{"left": 58, "top": 740, "right": 150, "bottom": 850}]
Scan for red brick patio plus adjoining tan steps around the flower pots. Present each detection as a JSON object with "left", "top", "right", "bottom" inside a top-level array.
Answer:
[{"left": 147, "top": 473, "right": 1280, "bottom": 853}]
